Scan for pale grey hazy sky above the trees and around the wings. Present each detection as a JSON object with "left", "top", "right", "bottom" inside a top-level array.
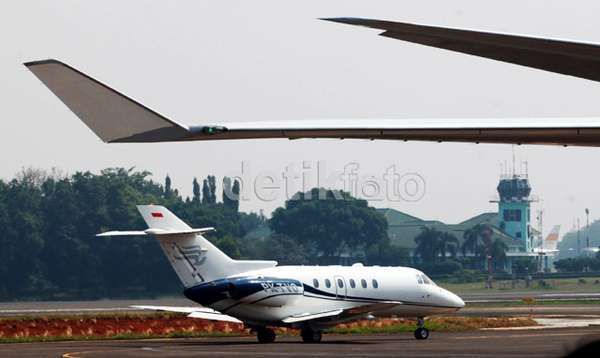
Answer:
[{"left": 0, "top": 0, "right": 600, "bottom": 241}]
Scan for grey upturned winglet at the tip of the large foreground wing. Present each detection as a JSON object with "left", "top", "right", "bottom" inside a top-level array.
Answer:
[{"left": 25, "top": 60, "right": 190, "bottom": 142}]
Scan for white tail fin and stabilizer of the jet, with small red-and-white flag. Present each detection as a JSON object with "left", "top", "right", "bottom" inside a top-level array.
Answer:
[{"left": 98, "top": 205, "right": 277, "bottom": 287}]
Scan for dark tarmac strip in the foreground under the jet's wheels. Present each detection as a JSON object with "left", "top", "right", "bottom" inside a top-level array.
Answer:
[{"left": 0, "top": 327, "right": 600, "bottom": 358}]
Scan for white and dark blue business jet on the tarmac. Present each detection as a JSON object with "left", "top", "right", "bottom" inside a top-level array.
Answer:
[{"left": 98, "top": 205, "right": 465, "bottom": 343}]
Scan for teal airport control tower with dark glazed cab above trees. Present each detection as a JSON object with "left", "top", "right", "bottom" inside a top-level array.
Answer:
[{"left": 497, "top": 173, "right": 536, "bottom": 252}]
